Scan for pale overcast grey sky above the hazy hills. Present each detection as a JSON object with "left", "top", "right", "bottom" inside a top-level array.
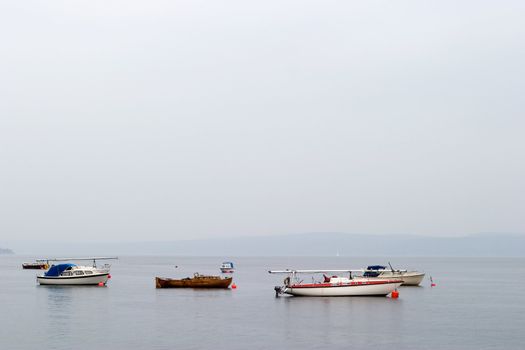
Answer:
[{"left": 0, "top": 0, "right": 525, "bottom": 241}]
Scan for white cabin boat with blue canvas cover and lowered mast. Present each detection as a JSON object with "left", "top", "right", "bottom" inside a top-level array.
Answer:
[{"left": 36, "top": 258, "right": 116, "bottom": 286}]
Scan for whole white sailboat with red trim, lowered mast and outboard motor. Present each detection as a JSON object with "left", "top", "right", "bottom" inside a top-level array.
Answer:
[{"left": 268, "top": 270, "right": 403, "bottom": 297}]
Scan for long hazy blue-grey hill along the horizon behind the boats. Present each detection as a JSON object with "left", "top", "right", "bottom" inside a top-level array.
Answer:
[{"left": 5, "top": 233, "right": 525, "bottom": 257}]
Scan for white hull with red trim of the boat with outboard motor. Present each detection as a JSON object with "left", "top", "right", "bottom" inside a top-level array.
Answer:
[{"left": 283, "top": 280, "right": 402, "bottom": 297}]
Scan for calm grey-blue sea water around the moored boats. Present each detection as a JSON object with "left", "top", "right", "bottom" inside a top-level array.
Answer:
[{"left": 0, "top": 256, "right": 525, "bottom": 350}]
